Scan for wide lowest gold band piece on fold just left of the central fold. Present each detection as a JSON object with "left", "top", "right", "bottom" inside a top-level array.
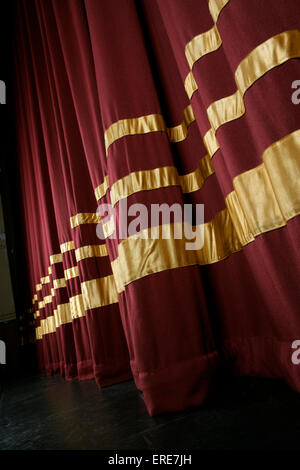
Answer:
[{"left": 81, "top": 275, "right": 118, "bottom": 310}]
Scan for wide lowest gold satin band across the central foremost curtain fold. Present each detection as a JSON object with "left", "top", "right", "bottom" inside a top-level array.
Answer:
[{"left": 111, "top": 213, "right": 241, "bottom": 293}]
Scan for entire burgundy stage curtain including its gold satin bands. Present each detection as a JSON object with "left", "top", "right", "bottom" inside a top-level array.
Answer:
[{"left": 15, "top": 0, "right": 300, "bottom": 415}]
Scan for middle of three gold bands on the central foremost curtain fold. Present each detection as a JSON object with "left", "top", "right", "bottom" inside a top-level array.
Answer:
[{"left": 110, "top": 155, "right": 214, "bottom": 206}]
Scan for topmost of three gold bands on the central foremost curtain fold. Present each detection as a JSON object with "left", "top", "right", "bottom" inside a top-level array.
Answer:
[{"left": 104, "top": 105, "right": 195, "bottom": 155}]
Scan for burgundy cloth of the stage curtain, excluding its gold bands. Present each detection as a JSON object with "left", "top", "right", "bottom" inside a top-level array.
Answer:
[{"left": 16, "top": 0, "right": 300, "bottom": 415}]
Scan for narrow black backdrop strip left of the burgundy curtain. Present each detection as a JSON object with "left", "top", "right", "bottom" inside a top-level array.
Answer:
[{"left": 0, "top": 0, "right": 35, "bottom": 377}]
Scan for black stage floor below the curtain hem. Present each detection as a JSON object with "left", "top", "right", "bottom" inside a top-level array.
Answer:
[{"left": 0, "top": 375, "right": 300, "bottom": 450}]
